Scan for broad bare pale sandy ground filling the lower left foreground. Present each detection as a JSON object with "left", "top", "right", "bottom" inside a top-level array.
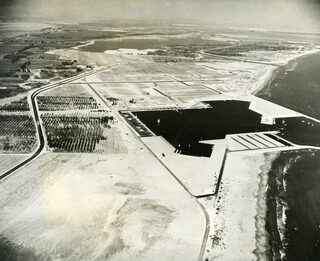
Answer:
[{"left": 0, "top": 123, "right": 205, "bottom": 260}]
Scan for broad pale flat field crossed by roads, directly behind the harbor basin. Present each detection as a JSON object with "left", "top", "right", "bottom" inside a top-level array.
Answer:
[{"left": 81, "top": 60, "right": 273, "bottom": 109}]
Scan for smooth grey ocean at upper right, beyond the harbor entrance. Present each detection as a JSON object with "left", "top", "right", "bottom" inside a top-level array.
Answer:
[{"left": 256, "top": 52, "right": 320, "bottom": 119}]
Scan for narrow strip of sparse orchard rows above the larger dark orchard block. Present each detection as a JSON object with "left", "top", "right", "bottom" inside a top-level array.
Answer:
[{"left": 37, "top": 96, "right": 98, "bottom": 111}]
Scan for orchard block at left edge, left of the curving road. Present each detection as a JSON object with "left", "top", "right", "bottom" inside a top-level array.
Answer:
[{"left": 0, "top": 115, "right": 37, "bottom": 152}]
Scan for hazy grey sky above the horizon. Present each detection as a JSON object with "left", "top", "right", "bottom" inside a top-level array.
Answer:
[{"left": 0, "top": 0, "right": 320, "bottom": 32}]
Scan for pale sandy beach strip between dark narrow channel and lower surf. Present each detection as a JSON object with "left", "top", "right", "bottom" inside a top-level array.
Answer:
[{"left": 207, "top": 152, "right": 277, "bottom": 261}]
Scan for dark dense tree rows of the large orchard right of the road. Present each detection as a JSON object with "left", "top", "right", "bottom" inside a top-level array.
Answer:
[{"left": 41, "top": 113, "right": 113, "bottom": 153}]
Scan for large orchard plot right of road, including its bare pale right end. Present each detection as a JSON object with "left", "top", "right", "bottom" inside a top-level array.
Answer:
[{"left": 41, "top": 113, "right": 125, "bottom": 153}]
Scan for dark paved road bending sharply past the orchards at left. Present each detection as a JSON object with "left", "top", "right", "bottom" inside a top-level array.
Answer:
[{"left": 0, "top": 67, "right": 107, "bottom": 180}]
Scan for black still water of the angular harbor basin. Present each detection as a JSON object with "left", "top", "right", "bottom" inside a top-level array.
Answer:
[{"left": 133, "top": 100, "right": 277, "bottom": 157}]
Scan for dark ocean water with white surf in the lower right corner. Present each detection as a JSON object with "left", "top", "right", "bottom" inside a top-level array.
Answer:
[{"left": 266, "top": 150, "right": 320, "bottom": 261}]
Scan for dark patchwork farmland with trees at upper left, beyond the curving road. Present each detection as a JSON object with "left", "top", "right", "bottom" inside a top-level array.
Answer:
[{"left": 0, "top": 25, "right": 111, "bottom": 98}]
